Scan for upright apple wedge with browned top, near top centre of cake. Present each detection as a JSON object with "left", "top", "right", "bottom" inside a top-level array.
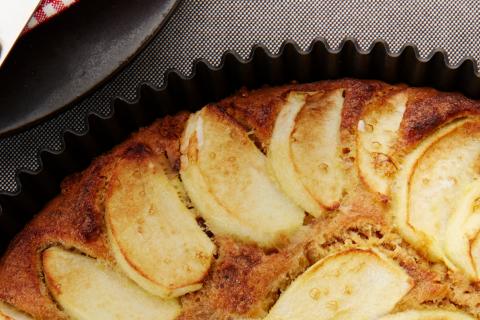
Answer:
[{"left": 268, "top": 89, "right": 345, "bottom": 217}]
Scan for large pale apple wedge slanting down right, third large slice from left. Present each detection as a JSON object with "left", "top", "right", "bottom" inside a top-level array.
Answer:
[{"left": 180, "top": 106, "right": 304, "bottom": 247}]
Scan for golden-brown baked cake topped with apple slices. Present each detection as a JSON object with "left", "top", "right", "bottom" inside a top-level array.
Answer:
[{"left": 0, "top": 79, "right": 480, "bottom": 320}]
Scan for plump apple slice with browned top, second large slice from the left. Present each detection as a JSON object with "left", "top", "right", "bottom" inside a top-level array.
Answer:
[{"left": 105, "top": 148, "right": 215, "bottom": 298}]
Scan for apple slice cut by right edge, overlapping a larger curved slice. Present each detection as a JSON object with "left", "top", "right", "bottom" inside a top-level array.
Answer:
[{"left": 445, "top": 180, "right": 480, "bottom": 280}]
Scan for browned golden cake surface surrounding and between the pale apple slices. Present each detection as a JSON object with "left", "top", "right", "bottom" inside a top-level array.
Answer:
[{"left": 0, "top": 79, "right": 480, "bottom": 320}]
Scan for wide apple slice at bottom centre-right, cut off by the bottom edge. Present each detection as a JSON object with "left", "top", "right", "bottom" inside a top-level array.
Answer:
[{"left": 266, "top": 249, "right": 413, "bottom": 320}]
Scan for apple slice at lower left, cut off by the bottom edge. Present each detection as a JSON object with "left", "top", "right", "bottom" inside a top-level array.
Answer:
[{"left": 43, "top": 247, "right": 180, "bottom": 320}]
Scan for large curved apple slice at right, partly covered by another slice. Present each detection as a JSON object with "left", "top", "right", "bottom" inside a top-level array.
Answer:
[{"left": 392, "top": 119, "right": 480, "bottom": 269}]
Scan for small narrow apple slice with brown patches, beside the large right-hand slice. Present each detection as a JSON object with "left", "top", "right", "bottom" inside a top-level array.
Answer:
[{"left": 357, "top": 92, "right": 408, "bottom": 195}]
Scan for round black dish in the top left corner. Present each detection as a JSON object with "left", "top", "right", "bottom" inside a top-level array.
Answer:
[{"left": 0, "top": 0, "right": 179, "bottom": 136}]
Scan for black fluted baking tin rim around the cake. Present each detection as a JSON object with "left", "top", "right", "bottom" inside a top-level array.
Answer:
[{"left": 0, "top": 39, "right": 480, "bottom": 253}]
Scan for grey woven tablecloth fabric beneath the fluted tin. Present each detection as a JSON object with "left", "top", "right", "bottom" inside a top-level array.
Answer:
[{"left": 0, "top": 0, "right": 480, "bottom": 192}]
